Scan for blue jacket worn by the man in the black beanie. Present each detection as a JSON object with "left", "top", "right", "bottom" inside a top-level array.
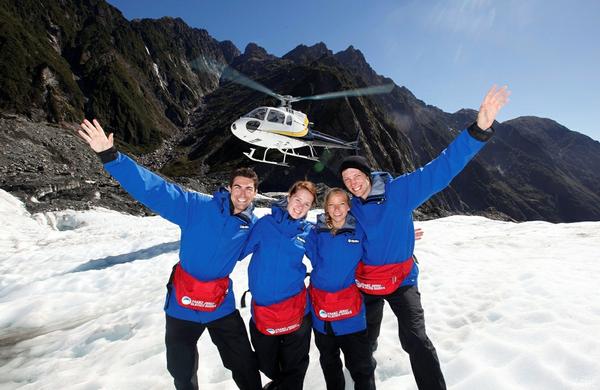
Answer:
[{"left": 351, "top": 130, "right": 485, "bottom": 286}]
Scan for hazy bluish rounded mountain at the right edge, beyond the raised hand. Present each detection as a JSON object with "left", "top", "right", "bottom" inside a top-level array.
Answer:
[{"left": 481, "top": 117, "right": 600, "bottom": 222}]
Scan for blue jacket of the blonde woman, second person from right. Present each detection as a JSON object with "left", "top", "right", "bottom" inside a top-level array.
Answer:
[{"left": 306, "top": 214, "right": 367, "bottom": 335}]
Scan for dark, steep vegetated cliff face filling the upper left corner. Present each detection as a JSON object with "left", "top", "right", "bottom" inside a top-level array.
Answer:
[{"left": 0, "top": 0, "right": 234, "bottom": 152}]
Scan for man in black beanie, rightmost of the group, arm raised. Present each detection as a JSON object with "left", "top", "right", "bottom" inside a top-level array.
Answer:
[{"left": 339, "top": 86, "right": 509, "bottom": 390}]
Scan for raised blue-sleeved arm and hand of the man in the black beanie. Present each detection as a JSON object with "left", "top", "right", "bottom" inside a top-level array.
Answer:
[{"left": 388, "top": 85, "right": 510, "bottom": 210}]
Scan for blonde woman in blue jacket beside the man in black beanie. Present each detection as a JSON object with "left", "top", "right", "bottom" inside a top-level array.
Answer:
[{"left": 306, "top": 188, "right": 375, "bottom": 390}]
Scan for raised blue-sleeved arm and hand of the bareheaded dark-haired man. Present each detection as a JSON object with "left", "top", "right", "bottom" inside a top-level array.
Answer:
[{"left": 78, "top": 119, "right": 211, "bottom": 226}]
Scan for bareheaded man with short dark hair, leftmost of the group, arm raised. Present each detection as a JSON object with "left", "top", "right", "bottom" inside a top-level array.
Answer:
[{"left": 79, "top": 119, "right": 261, "bottom": 390}]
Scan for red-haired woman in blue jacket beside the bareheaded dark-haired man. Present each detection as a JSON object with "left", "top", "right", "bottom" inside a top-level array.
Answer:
[{"left": 243, "top": 181, "right": 316, "bottom": 390}]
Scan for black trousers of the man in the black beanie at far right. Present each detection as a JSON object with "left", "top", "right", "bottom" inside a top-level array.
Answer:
[{"left": 363, "top": 286, "right": 446, "bottom": 390}]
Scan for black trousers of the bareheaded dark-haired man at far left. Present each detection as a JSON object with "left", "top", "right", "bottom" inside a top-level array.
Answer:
[{"left": 165, "top": 310, "right": 262, "bottom": 390}]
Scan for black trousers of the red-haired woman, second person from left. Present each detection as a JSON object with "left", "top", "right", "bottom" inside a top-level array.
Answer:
[{"left": 250, "top": 314, "right": 312, "bottom": 390}]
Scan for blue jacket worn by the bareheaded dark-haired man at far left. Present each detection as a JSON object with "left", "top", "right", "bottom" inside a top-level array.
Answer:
[{"left": 104, "top": 153, "right": 257, "bottom": 323}]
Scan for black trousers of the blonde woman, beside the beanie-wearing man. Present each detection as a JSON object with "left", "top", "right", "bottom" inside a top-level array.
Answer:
[{"left": 314, "top": 326, "right": 375, "bottom": 390}]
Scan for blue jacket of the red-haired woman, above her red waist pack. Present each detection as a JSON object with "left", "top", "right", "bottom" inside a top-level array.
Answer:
[{"left": 242, "top": 206, "right": 313, "bottom": 313}]
